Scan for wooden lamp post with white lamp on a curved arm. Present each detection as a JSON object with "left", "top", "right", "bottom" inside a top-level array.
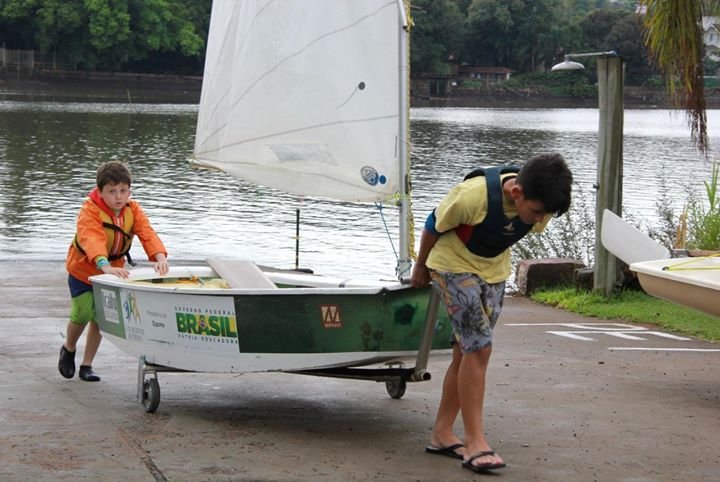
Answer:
[{"left": 551, "top": 51, "right": 623, "bottom": 295}]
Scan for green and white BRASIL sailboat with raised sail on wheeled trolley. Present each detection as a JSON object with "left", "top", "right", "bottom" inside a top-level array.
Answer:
[{"left": 92, "top": 0, "right": 450, "bottom": 412}]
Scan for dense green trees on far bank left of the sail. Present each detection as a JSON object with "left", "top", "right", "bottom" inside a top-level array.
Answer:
[{"left": 0, "top": 0, "right": 211, "bottom": 70}]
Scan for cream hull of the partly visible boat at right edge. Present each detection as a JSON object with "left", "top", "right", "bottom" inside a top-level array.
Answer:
[{"left": 630, "top": 257, "right": 720, "bottom": 317}]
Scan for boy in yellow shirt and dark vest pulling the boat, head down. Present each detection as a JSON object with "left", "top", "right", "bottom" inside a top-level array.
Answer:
[{"left": 411, "top": 154, "right": 572, "bottom": 472}]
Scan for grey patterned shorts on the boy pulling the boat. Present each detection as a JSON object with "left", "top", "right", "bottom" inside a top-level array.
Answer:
[{"left": 430, "top": 269, "right": 505, "bottom": 353}]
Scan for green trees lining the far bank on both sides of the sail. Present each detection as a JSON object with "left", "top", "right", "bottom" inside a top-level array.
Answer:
[{"left": 0, "top": 0, "right": 668, "bottom": 81}]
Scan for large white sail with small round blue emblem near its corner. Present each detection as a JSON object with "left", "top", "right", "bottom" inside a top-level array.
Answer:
[{"left": 195, "top": 0, "right": 407, "bottom": 201}]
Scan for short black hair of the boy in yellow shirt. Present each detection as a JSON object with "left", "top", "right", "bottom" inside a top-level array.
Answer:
[{"left": 516, "top": 154, "right": 572, "bottom": 217}]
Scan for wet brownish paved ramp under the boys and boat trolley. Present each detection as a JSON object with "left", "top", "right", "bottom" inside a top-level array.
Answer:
[{"left": 0, "top": 261, "right": 720, "bottom": 482}]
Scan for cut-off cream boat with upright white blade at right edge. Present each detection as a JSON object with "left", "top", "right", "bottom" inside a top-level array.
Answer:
[{"left": 601, "top": 209, "right": 720, "bottom": 317}]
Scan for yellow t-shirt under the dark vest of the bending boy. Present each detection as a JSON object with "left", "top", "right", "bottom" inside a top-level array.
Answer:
[{"left": 426, "top": 173, "right": 552, "bottom": 283}]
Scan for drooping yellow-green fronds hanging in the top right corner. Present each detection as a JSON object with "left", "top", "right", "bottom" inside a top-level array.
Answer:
[{"left": 640, "top": 0, "right": 708, "bottom": 153}]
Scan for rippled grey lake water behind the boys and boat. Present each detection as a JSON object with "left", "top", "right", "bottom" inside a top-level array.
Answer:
[{"left": 0, "top": 101, "right": 720, "bottom": 277}]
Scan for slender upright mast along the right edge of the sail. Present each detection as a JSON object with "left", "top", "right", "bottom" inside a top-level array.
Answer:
[{"left": 395, "top": 0, "right": 412, "bottom": 279}]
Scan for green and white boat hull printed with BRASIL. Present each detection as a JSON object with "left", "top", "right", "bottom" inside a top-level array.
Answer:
[{"left": 88, "top": 267, "right": 451, "bottom": 372}]
